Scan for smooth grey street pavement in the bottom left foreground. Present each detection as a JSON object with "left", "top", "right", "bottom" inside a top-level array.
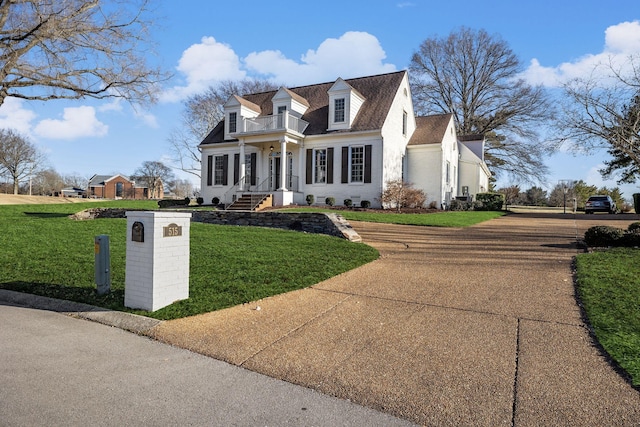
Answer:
[{"left": 0, "top": 298, "right": 410, "bottom": 426}]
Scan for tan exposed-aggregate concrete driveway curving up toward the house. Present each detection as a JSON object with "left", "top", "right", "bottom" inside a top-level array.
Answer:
[{"left": 150, "top": 214, "right": 640, "bottom": 426}]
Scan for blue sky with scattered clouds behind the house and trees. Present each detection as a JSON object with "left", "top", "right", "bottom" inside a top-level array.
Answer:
[{"left": 0, "top": 0, "right": 640, "bottom": 198}]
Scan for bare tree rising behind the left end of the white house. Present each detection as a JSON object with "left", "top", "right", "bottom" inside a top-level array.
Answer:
[{"left": 169, "top": 79, "right": 278, "bottom": 177}]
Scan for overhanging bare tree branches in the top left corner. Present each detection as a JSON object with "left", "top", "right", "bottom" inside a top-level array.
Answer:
[{"left": 0, "top": 0, "right": 167, "bottom": 105}]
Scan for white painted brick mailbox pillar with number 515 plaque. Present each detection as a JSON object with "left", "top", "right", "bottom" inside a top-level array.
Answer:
[{"left": 124, "top": 211, "right": 191, "bottom": 311}]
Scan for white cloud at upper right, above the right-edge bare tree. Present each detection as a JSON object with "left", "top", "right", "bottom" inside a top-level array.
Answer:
[{"left": 522, "top": 21, "right": 640, "bottom": 87}]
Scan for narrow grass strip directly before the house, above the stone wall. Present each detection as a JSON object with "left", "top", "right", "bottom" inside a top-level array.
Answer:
[{"left": 281, "top": 207, "right": 505, "bottom": 227}]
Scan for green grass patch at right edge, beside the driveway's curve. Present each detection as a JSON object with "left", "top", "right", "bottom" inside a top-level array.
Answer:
[{"left": 576, "top": 248, "right": 640, "bottom": 386}]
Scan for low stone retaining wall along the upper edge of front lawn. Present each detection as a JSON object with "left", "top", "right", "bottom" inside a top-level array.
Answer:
[{"left": 70, "top": 208, "right": 362, "bottom": 242}]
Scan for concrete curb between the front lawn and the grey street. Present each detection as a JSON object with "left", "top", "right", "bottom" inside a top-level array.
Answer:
[{"left": 0, "top": 289, "right": 162, "bottom": 335}]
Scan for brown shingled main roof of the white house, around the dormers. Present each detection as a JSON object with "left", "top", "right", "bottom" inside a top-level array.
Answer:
[{"left": 202, "top": 71, "right": 406, "bottom": 144}]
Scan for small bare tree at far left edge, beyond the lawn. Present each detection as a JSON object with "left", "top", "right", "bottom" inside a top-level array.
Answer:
[{"left": 0, "top": 129, "right": 44, "bottom": 194}]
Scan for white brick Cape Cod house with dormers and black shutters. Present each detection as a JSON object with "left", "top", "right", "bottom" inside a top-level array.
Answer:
[{"left": 200, "top": 71, "right": 489, "bottom": 209}]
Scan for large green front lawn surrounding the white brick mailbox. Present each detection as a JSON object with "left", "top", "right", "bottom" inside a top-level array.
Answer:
[{"left": 0, "top": 201, "right": 378, "bottom": 319}]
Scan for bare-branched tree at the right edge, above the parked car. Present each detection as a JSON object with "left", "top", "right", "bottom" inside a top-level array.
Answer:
[{"left": 557, "top": 55, "right": 640, "bottom": 183}]
